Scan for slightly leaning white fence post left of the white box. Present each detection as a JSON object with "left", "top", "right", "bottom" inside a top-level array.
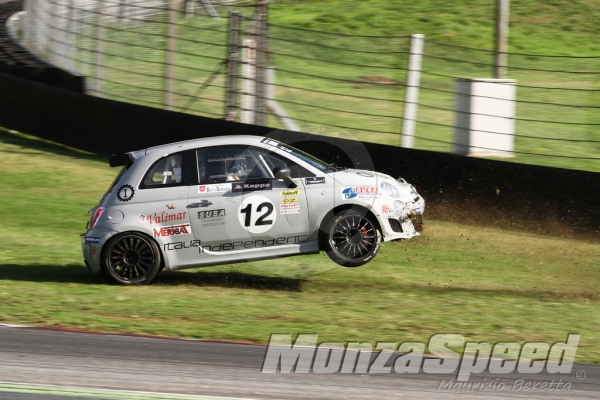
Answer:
[{"left": 401, "top": 34, "right": 425, "bottom": 149}]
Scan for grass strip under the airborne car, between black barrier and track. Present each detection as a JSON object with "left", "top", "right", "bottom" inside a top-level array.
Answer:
[{"left": 0, "top": 131, "right": 600, "bottom": 363}]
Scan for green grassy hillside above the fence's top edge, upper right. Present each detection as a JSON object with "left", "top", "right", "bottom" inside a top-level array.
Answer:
[{"left": 270, "top": 0, "right": 600, "bottom": 56}]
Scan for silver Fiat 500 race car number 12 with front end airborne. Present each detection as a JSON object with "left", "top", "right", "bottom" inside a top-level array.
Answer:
[{"left": 81, "top": 136, "right": 425, "bottom": 284}]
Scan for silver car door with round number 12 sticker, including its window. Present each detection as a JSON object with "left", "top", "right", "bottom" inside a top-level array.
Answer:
[{"left": 188, "top": 145, "right": 308, "bottom": 262}]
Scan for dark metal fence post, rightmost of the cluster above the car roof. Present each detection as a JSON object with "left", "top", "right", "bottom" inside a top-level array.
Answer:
[{"left": 255, "top": 1, "right": 268, "bottom": 126}]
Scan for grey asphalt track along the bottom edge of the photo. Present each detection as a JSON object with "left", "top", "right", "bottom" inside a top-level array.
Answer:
[{"left": 0, "top": 326, "right": 600, "bottom": 400}]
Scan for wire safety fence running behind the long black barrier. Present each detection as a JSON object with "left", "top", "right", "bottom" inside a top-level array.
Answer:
[{"left": 10, "top": 0, "right": 600, "bottom": 171}]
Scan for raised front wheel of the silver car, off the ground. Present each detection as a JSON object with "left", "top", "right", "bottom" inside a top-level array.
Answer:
[{"left": 324, "top": 210, "right": 381, "bottom": 267}]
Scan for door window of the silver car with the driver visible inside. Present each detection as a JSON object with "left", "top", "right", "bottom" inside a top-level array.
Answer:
[{"left": 197, "top": 146, "right": 269, "bottom": 184}]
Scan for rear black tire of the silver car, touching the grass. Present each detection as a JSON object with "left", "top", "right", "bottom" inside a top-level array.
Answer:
[{"left": 102, "top": 232, "right": 161, "bottom": 285}]
